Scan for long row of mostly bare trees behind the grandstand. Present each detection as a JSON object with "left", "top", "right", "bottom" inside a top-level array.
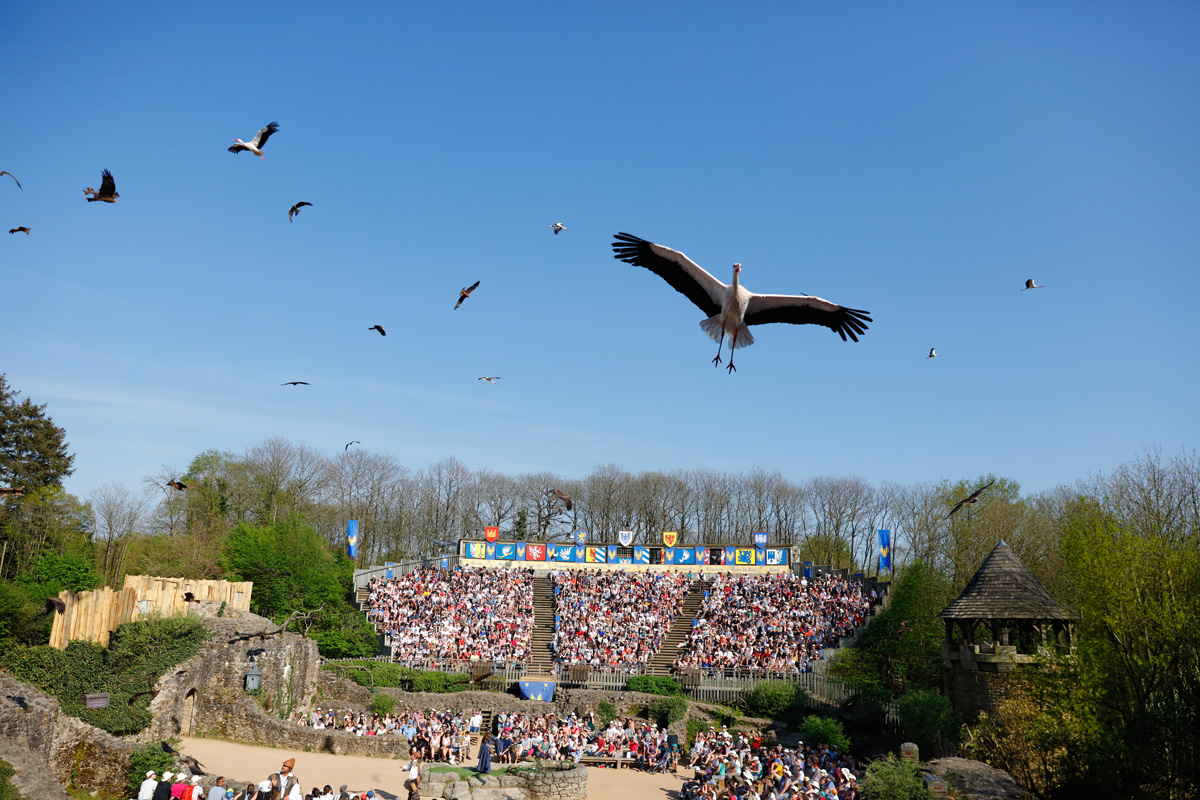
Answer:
[{"left": 8, "top": 439, "right": 1060, "bottom": 583}]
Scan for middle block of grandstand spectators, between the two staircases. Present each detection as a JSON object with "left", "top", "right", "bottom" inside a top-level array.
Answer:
[{"left": 553, "top": 570, "right": 691, "bottom": 670}]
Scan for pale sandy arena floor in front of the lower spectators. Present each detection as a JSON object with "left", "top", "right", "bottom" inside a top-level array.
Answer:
[{"left": 179, "top": 739, "right": 691, "bottom": 800}]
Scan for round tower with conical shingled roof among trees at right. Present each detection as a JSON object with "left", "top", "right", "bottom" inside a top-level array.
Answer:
[{"left": 938, "top": 540, "right": 1075, "bottom": 722}]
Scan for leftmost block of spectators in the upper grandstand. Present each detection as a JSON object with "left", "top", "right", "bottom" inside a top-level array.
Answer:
[{"left": 367, "top": 567, "right": 533, "bottom": 664}]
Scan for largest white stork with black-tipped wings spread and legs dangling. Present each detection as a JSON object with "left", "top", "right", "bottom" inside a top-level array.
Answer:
[{"left": 612, "top": 234, "right": 872, "bottom": 374}]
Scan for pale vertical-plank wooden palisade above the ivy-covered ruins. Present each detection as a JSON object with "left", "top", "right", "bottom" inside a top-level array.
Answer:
[{"left": 50, "top": 575, "right": 254, "bottom": 650}]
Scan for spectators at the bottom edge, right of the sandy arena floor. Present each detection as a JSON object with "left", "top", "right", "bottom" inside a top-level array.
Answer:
[{"left": 683, "top": 727, "right": 860, "bottom": 800}]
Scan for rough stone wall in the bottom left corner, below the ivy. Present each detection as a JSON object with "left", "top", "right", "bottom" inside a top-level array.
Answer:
[{"left": 0, "top": 672, "right": 138, "bottom": 792}]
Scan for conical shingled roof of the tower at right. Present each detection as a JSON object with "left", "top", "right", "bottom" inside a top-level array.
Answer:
[{"left": 938, "top": 540, "right": 1075, "bottom": 620}]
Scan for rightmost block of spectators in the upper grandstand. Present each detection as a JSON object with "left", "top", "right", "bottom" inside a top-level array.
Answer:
[{"left": 674, "top": 572, "right": 872, "bottom": 674}]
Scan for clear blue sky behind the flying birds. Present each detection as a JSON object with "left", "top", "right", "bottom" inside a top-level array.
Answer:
[{"left": 0, "top": 2, "right": 1200, "bottom": 495}]
